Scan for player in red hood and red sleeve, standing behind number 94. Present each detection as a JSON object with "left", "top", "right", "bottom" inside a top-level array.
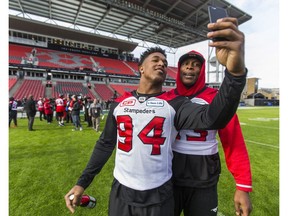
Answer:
[{"left": 172, "top": 51, "right": 252, "bottom": 216}]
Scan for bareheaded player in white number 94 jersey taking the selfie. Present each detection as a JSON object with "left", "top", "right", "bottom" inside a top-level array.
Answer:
[{"left": 65, "top": 18, "right": 247, "bottom": 216}]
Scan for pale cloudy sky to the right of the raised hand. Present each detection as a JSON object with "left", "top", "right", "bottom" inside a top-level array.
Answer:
[{"left": 214, "top": 0, "right": 280, "bottom": 88}]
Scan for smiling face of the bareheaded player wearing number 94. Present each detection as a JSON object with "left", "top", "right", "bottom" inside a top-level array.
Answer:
[{"left": 140, "top": 52, "right": 167, "bottom": 82}]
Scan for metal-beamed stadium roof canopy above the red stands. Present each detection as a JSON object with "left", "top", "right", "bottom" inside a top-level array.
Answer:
[{"left": 9, "top": 0, "right": 252, "bottom": 52}]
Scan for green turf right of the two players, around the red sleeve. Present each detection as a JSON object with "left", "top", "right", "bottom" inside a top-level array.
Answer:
[{"left": 218, "top": 107, "right": 279, "bottom": 216}]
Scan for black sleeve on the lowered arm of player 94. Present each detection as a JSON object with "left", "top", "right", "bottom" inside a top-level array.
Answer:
[{"left": 76, "top": 103, "right": 117, "bottom": 189}]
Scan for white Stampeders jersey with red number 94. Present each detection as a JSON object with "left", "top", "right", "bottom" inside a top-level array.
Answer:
[{"left": 114, "top": 96, "right": 177, "bottom": 190}]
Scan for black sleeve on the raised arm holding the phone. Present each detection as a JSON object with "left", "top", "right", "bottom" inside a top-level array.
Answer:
[{"left": 175, "top": 70, "right": 247, "bottom": 130}]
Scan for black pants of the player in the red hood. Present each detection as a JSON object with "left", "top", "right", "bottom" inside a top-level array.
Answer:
[{"left": 174, "top": 185, "right": 218, "bottom": 216}]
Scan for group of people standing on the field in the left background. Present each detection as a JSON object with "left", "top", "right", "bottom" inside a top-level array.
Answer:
[{"left": 9, "top": 94, "right": 104, "bottom": 132}]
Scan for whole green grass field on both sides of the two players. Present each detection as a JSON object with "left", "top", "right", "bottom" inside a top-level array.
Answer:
[{"left": 9, "top": 107, "right": 279, "bottom": 216}]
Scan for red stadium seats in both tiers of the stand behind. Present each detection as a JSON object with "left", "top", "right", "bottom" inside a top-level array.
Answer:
[{"left": 9, "top": 43, "right": 177, "bottom": 101}]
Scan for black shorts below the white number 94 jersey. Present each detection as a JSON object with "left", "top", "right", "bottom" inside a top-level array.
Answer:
[{"left": 108, "top": 179, "right": 174, "bottom": 216}]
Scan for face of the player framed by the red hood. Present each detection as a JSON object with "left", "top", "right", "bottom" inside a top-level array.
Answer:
[{"left": 180, "top": 58, "right": 202, "bottom": 87}]
